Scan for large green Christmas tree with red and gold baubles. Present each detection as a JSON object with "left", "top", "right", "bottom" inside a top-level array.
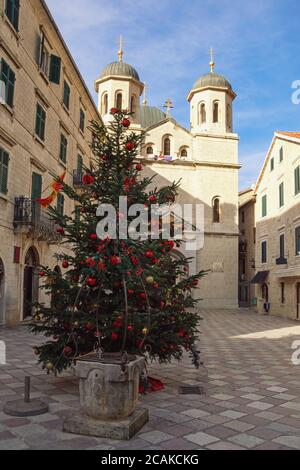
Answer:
[{"left": 30, "top": 109, "right": 204, "bottom": 373}]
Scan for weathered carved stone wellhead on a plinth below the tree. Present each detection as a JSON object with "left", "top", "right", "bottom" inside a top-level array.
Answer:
[{"left": 64, "top": 357, "right": 148, "bottom": 439}]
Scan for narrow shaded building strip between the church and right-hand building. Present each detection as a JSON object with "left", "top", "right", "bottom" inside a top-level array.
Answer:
[{"left": 239, "top": 188, "right": 256, "bottom": 307}]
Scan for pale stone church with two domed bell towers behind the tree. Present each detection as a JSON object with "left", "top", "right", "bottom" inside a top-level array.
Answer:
[{"left": 95, "top": 47, "right": 240, "bottom": 309}]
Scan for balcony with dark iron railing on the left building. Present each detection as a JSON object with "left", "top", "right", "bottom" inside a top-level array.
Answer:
[{"left": 14, "top": 196, "right": 61, "bottom": 244}]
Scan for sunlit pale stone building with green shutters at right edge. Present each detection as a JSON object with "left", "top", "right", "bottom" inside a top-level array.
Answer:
[{"left": 253, "top": 132, "right": 300, "bottom": 320}]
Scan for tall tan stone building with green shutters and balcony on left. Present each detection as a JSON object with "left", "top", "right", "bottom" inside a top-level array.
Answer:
[{"left": 0, "top": 0, "right": 100, "bottom": 324}]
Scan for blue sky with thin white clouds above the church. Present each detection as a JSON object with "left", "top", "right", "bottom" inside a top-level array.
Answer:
[{"left": 47, "top": 0, "right": 300, "bottom": 189}]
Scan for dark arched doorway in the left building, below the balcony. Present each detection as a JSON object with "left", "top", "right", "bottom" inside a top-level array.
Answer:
[{"left": 23, "top": 247, "right": 39, "bottom": 320}]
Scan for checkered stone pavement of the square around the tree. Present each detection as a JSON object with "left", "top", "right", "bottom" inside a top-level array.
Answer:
[{"left": 0, "top": 309, "right": 300, "bottom": 450}]
